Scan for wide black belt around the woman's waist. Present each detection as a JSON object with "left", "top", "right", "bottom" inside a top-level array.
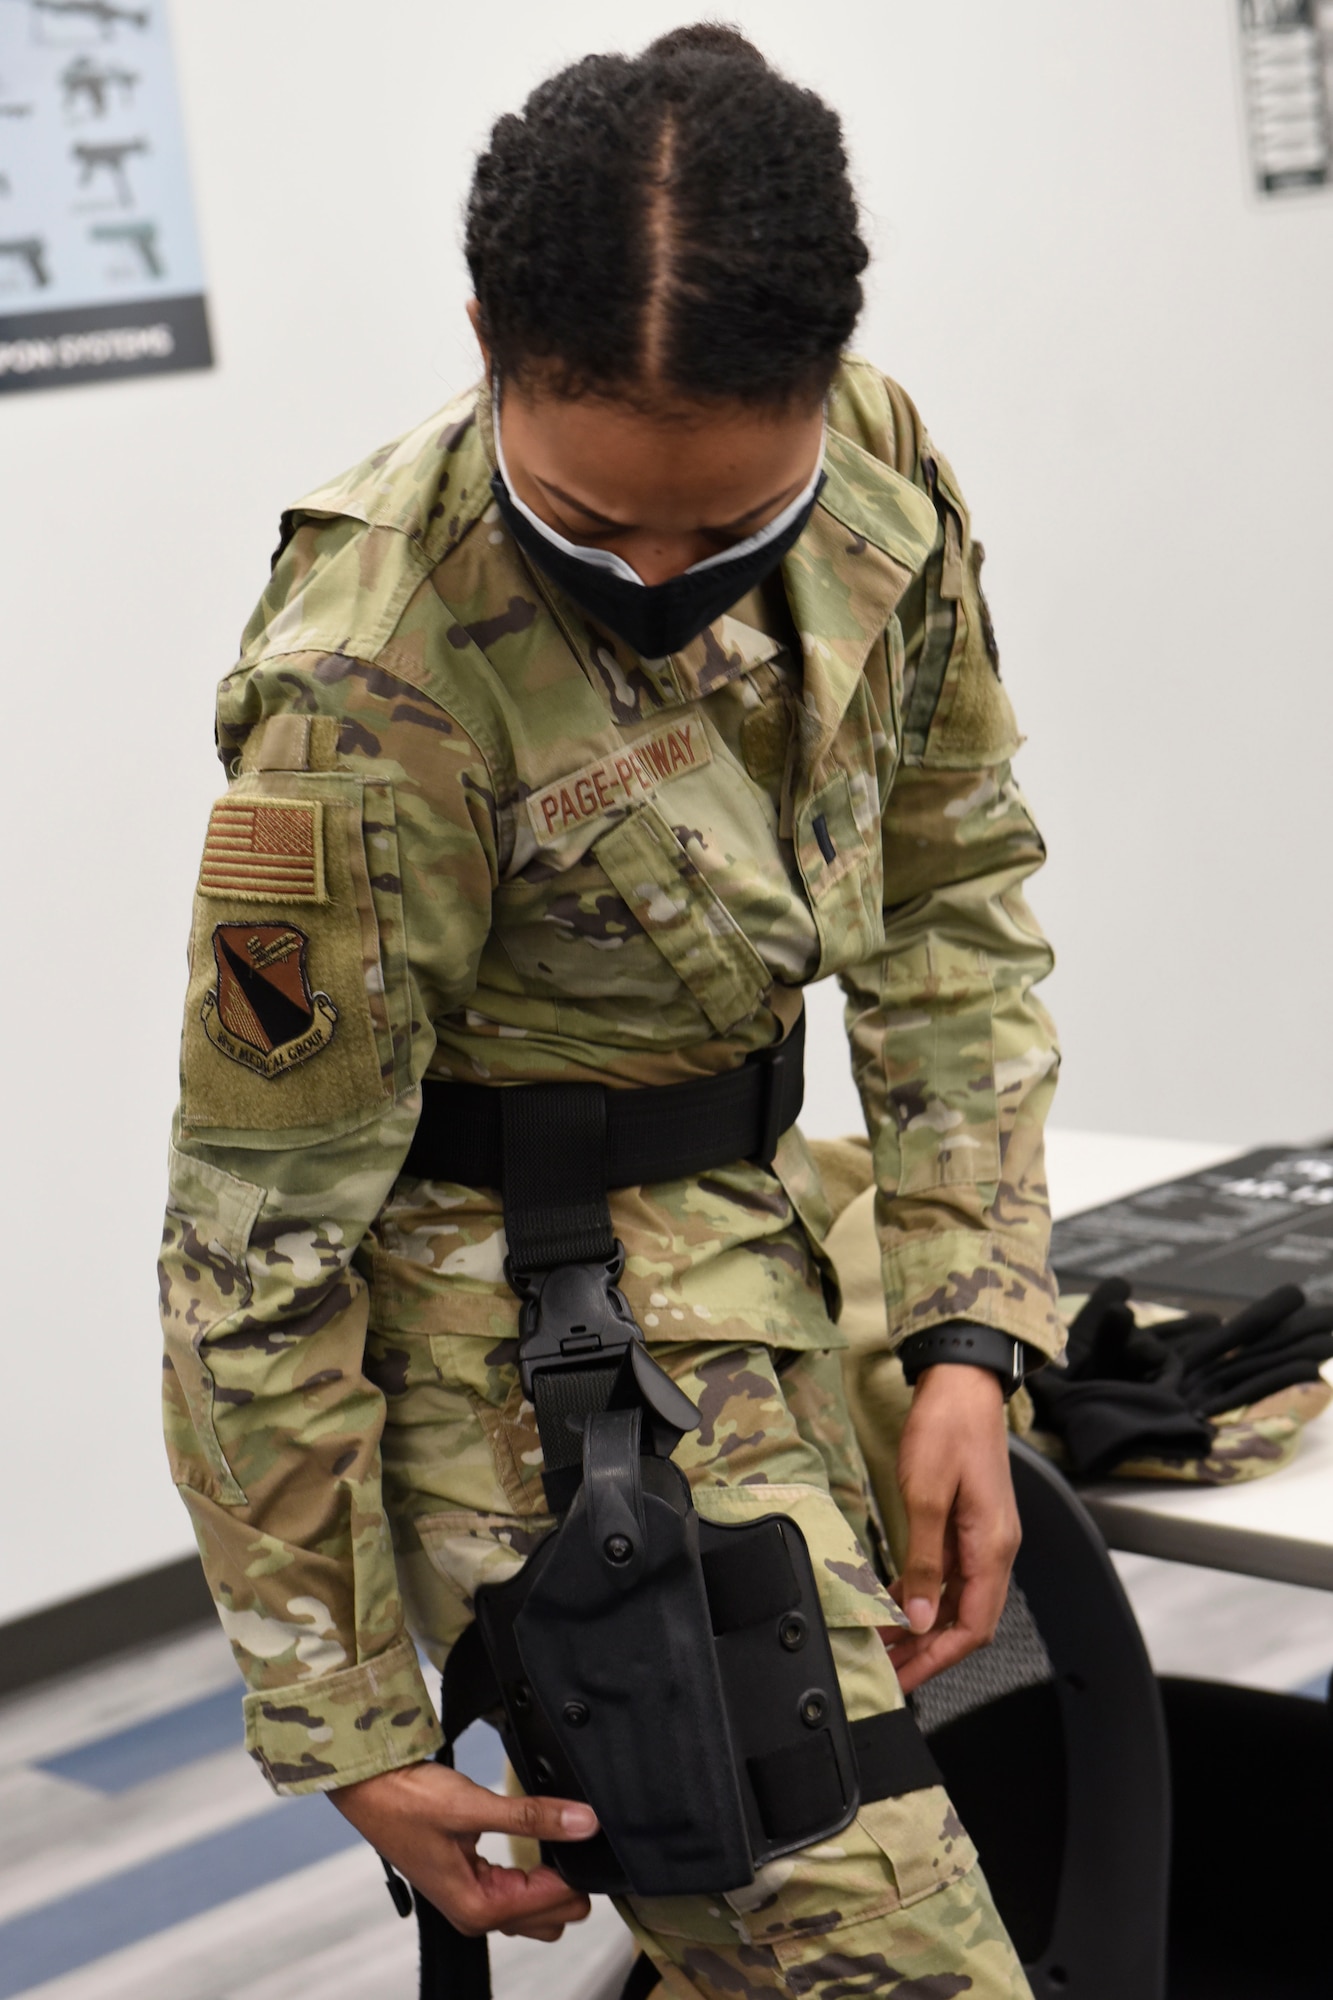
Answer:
[{"left": 404, "top": 1014, "right": 805, "bottom": 1188}]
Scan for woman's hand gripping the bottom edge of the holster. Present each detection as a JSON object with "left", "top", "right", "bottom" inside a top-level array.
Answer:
[{"left": 328, "top": 1764, "right": 596, "bottom": 1944}]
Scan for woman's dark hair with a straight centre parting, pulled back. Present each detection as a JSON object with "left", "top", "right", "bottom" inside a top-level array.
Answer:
[{"left": 466, "top": 24, "right": 867, "bottom": 404}]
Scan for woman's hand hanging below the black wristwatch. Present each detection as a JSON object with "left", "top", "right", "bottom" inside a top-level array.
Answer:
[{"left": 881, "top": 1362, "right": 1021, "bottom": 1694}]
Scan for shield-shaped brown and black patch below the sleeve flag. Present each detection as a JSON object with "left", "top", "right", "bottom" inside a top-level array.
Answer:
[{"left": 200, "top": 924, "right": 338, "bottom": 1080}]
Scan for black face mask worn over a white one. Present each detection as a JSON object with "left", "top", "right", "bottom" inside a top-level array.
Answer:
[{"left": 490, "top": 472, "right": 825, "bottom": 660}]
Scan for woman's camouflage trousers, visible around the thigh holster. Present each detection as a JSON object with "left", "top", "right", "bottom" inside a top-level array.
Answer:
[{"left": 370, "top": 1332, "right": 1031, "bottom": 2000}]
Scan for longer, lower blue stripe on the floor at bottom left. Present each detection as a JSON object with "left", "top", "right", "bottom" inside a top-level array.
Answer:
[{"left": 0, "top": 1798, "right": 360, "bottom": 2000}]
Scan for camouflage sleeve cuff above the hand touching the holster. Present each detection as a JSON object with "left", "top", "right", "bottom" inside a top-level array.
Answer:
[{"left": 244, "top": 1638, "right": 442, "bottom": 1796}]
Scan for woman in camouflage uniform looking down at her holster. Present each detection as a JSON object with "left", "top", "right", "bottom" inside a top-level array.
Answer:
[{"left": 164, "top": 28, "right": 1059, "bottom": 1996}]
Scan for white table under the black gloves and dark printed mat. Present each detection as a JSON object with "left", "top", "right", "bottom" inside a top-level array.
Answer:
[{"left": 1049, "top": 1130, "right": 1333, "bottom": 1590}]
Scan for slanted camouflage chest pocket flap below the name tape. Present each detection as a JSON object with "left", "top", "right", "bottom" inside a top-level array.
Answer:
[{"left": 592, "top": 800, "right": 773, "bottom": 1034}]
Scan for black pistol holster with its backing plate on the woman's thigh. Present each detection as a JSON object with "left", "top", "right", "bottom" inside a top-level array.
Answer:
[{"left": 476, "top": 1304, "right": 857, "bottom": 1896}]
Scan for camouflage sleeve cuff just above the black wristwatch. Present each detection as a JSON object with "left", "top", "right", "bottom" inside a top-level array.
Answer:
[{"left": 885, "top": 1230, "right": 1065, "bottom": 1358}]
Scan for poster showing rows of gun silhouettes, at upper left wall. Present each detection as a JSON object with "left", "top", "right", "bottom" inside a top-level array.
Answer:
[{"left": 0, "top": 0, "right": 212, "bottom": 394}]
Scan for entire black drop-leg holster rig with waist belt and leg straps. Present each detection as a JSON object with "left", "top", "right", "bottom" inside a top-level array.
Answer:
[{"left": 390, "top": 1034, "right": 941, "bottom": 2000}]
